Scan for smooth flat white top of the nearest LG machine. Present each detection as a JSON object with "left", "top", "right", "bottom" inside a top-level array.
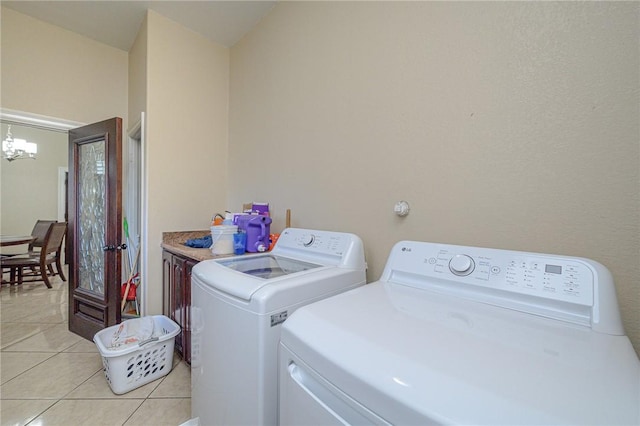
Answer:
[{"left": 281, "top": 282, "right": 640, "bottom": 425}]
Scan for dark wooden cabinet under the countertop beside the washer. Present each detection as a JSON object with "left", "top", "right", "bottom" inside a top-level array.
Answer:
[{"left": 162, "top": 250, "right": 198, "bottom": 364}]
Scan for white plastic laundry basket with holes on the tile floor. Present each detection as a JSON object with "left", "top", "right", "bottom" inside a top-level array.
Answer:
[{"left": 93, "top": 315, "right": 180, "bottom": 394}]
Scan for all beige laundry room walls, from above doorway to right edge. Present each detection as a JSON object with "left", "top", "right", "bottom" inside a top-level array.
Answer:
[{"left": 0, "top": 2, "right": 640, "bottom": 356}]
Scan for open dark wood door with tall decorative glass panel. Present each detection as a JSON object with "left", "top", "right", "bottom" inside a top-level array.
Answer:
[{"left": 67, "top": 117, "right": 123, "bottom": 340}]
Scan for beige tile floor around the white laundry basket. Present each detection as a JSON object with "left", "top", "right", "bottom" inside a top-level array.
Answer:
[{"left": 0, "top": 277, "right": 191, "bottom": 426}]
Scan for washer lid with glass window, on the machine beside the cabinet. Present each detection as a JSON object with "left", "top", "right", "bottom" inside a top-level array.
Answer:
[{"left": 192, "top": 254, "right": 322, "bottom": 301}]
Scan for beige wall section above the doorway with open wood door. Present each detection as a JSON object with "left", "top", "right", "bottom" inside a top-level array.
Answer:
[{"left": 0, "top": 7, "right": 128, "bottom": 128}]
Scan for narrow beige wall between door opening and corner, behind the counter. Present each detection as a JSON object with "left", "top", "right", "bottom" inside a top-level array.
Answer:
[{"left": 146, "top": 11, "right": 229, "bottom": 314}]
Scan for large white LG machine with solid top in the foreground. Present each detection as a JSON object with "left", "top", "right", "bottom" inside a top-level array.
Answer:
[{"left": 280, "top": 241, "right": 640, "bottom": 425}]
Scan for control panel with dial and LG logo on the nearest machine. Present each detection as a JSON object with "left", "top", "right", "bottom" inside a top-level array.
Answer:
[{"left": 385, "top": 241, "right": 595, "bottom": 306}]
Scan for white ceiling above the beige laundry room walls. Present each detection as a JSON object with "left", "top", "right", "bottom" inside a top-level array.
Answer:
[{"left": 2, "top": 0, "right": 276, "bottom": 52}]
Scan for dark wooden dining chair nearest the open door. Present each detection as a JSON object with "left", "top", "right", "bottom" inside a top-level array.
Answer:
[{"left": 1, "top": 222, "right": 67, "bottom": 288}]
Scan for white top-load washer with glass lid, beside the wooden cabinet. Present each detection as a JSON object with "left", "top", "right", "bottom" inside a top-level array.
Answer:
[{"left": 191, "top": 228, "right": 366, "bottom": 426}]
